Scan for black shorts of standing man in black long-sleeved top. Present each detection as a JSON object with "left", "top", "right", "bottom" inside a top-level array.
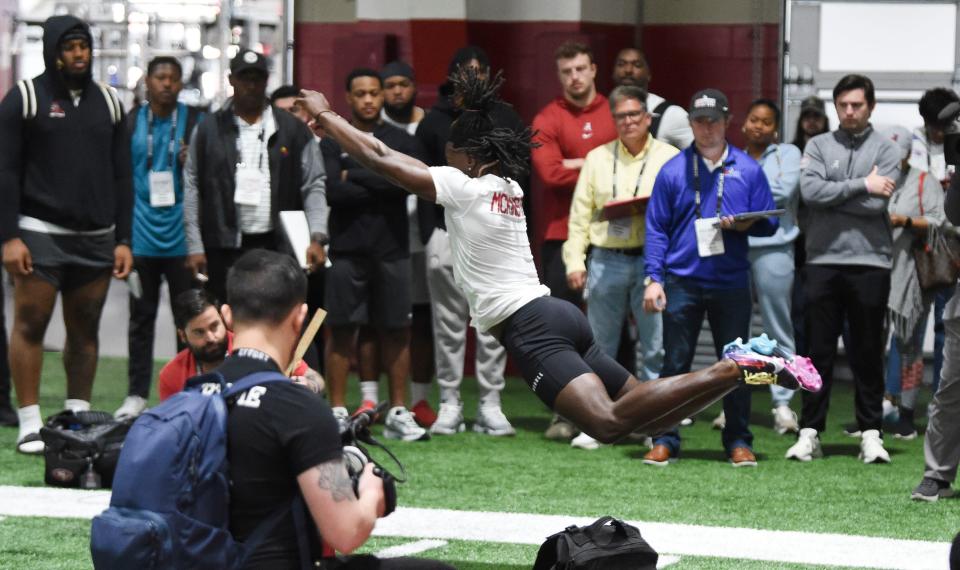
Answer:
[{"left": 324, "top": 256, "right": 411, "bottom": 329}]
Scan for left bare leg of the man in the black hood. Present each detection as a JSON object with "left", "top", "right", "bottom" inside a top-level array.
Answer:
[{"left": 10, "top": 275, "right": 57, "bottom": 408}]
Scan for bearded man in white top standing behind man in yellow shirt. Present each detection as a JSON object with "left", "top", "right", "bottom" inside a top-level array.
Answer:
[{"left": 613, "top": 48, "right": 693, "bottom": 150}]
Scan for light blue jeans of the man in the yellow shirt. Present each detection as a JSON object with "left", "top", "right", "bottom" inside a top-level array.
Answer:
[{"left": 587, "top": 247, "right": 663, "bottom": 381}]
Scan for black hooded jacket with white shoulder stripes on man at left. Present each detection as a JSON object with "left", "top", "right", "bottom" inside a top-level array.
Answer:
[{"left": 0, "top": 16, "right": 133, "bottom": 243}]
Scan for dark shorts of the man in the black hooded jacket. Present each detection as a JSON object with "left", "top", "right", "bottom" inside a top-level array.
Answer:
[{"left": 20, "top": 230, "right": 116, "bottom": 291}]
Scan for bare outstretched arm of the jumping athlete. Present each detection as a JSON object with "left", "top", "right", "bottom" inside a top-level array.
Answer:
[{"left": 297, "top": 89, "right": 437, "bottom": 202}]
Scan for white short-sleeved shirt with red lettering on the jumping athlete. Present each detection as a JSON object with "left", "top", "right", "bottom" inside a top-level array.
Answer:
[{"left": 430, "top": 166, "right": 550, "bottom": 332}]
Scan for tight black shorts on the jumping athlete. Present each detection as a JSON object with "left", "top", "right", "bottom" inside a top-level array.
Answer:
[{"left": 500, "top": 297, "right": 630, "bottom": 409}]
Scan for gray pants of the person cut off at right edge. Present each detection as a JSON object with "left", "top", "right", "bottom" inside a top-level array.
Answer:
[{"left": 923, "top": 294, "right": 960, "bottom": 483}]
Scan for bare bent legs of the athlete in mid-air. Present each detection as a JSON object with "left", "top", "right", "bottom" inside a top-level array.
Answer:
[{"left": 554, "top": 360, "right": 740, "bottom": 443}]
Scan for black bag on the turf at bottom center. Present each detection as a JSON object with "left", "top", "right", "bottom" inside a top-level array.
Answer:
[{"left": 533, "top": 517, "right": 658, "bottom": 570}]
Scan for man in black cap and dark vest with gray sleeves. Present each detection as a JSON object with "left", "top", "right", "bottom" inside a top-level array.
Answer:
[{"left": 183, "top": 49, "right": 327, "bottom": 299}]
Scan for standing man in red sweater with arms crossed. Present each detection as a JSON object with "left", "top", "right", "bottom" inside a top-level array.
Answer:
[{"left": 531, "top": 42, "right": 617, "bottom": 441}]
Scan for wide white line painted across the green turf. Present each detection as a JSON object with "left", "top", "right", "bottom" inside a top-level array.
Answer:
[{"left": 0, "top": 486, "right": 950, "bottom": 570}]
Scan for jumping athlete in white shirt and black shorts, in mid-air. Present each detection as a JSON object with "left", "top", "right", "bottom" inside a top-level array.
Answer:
[{"left": 298, "top": 68, "right": 821, "bottom": 443}]
